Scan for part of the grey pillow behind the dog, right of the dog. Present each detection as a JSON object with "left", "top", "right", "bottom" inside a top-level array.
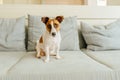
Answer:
[{"left": 60, "top": 17, "right": 79, "bottom": 50}]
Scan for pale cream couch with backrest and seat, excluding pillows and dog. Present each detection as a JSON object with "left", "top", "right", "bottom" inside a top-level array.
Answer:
[{"left": 0, "top": 5, "right": 120, "bottom": 80}]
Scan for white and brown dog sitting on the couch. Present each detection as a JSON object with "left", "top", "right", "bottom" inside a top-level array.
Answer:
[{"left": 36, "top": 16, "right": 64, "bottom": 62}]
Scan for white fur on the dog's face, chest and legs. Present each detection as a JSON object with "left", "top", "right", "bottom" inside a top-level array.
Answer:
[{"left": 36, "top": 20, "right": 61, "bottom": 62}]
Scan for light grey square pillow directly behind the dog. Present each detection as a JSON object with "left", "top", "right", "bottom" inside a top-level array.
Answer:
[{"left": 28, "top": 15, "right": 79, "bottom": 51}]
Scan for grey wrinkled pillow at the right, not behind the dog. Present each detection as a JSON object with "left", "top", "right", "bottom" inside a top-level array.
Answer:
[{"left": 81, "top": 19, "right": 120, "bottom": 50}]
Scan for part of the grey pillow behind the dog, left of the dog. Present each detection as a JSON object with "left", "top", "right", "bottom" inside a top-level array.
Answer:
[{"left": 27, "top": 15, "right": 45, "bottom": 51}]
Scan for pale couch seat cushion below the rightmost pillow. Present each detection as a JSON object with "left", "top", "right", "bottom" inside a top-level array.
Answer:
[{"left": 83, "top": 50, "right": 120, "bottom": 70}]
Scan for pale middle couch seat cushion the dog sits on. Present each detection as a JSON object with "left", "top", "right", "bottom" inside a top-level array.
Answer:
[{"left": 6, "top": 51, "right": 112, "bottom": 80}]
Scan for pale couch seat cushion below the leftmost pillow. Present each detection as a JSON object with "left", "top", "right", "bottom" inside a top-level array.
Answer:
[{"left": 0, "top": 52, "right": 26, "bottom": 74}]
